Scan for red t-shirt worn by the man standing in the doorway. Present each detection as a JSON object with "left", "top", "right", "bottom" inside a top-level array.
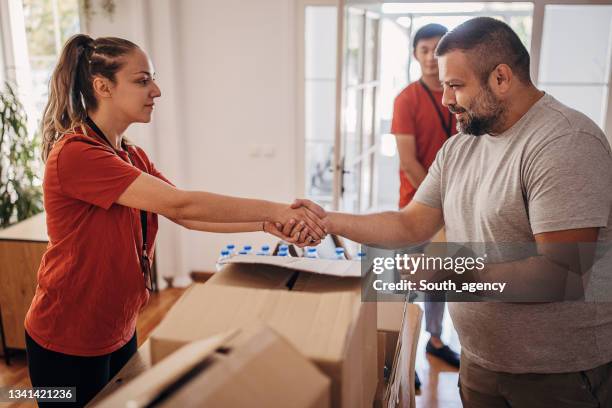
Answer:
[{"left": 391, "top": 81, "right": 457, "bottom": 208}]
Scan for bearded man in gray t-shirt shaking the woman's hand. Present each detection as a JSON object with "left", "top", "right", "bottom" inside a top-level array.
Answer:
[{"left": 283, "top": 17, "right": 612, "bottom": 408}]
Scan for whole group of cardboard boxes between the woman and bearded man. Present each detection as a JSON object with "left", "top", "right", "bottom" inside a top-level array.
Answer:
[{"left": 92, "top": 255, "right": 418, "bottom": 408}]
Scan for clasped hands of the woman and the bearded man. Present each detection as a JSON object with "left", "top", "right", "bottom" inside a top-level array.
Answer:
[{"left": 263, "top": 199, "right": 330, "bottom": 248}]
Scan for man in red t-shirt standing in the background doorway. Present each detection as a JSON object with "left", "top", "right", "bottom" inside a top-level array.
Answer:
[{"left": 391, "top": 24, "right": 459, "bottom": 389}]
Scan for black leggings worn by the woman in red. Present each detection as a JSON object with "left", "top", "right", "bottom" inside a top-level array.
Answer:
[{"left": 25, "top": 332, "right": 138, "bottom": 408}]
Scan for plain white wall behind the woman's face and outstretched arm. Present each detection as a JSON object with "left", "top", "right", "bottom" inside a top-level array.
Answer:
[{"left": 89, "top": 0, "right": 298, "bottom": 276}]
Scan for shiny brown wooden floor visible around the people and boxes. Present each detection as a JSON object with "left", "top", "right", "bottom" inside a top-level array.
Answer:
[{"left": 0, "top": 288, "right": 461, "bottom": 408}]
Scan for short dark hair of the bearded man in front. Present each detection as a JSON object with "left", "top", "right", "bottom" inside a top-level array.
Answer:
[{"left": 436, "top": 17, "right": 531, "bottom": 84}]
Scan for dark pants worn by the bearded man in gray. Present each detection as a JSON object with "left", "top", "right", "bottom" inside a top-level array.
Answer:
[{"left": 459, "top": 354, "right": 612, "bottom": 408}]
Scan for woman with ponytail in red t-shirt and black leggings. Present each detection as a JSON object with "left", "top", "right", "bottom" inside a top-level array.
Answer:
[{"left": 25, "top": 34, "right": 326, "bottom": 406}]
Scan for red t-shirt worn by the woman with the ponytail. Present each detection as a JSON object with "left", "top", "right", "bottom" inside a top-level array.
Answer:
[{"left": 25, "top": 128, "right": 169, "bottom": 356}]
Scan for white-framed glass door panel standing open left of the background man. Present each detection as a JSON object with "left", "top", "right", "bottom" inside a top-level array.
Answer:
[{"left": 335, "top": 6, "right": 380, "bottom": 213}]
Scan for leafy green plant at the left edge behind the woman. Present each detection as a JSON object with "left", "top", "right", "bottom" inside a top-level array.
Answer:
[{"left": 0, "top": 83, "right": 43, "bottom": 228}]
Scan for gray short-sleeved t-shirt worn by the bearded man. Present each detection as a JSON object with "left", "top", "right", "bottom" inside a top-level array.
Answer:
[{"left": 414, "top": 95, "right": 612, "bottom": 373}]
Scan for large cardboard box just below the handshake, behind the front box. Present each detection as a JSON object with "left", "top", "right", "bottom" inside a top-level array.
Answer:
[{"left": 151, "top": 255, "right": 378, "bottom": 408}]
